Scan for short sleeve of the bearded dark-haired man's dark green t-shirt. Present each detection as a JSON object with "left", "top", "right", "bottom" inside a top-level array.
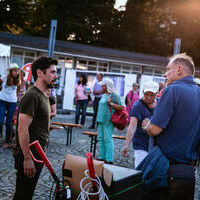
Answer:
[{"left": 19, "top": 93, "right": 39, "bottom": 117}]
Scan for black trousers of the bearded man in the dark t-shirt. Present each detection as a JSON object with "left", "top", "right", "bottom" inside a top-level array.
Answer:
[{"left": 13, "top": 156, "right": 43, "bottom": 200}]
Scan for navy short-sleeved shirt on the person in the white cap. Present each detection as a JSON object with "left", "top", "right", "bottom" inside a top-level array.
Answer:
[{"left": 130, "top": 100, "right": 154, "bottom": 151}]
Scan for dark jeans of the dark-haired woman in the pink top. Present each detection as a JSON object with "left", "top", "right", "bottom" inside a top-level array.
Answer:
[{"left": 75, "top": 99, "right": 88, "bottom": 125}]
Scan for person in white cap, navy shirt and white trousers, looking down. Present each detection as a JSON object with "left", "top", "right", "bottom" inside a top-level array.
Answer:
[{"left": 122, "top": 81, "right": 159, "bottom": 168}]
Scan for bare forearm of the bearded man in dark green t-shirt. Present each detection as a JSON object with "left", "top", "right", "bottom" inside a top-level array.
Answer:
[{"left": 18, "top": 127, "right": 31, "bottom": 160}]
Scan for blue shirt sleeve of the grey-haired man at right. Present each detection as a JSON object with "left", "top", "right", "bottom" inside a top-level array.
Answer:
[{"left": 151, "top": 87, "right": 175, "bottom": 128}]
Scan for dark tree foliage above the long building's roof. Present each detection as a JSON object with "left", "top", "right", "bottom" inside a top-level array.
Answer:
[{"left": 0, "top": 0, "right": 200, "bottom": 65}]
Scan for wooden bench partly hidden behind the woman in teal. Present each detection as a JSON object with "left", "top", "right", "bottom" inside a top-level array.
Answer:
[{"left": 82, "top": 131, "right": 126, "bottom": 157}]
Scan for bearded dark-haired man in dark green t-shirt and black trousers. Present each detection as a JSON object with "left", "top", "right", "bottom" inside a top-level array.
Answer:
[{"left": 13, "top": 57, "right": 58, "bottom": 200}]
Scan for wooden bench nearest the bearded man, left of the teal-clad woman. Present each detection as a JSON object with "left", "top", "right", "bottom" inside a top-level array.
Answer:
[{"left": 51, "top": 122, "right": 82, "bottom": 146}]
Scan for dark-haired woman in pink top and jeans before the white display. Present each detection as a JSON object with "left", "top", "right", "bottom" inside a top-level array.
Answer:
[{"left": 75, "top": 74, "right": 91, "bottom": 126}]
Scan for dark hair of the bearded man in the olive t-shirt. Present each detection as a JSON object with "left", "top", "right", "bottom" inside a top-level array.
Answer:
[{"left": 31, "top": 56, "right": 58, "bottom": 81}]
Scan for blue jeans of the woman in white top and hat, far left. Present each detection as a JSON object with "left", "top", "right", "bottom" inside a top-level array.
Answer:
[{"left": 0, "top": 100, "right": 17, "bottom": 143}]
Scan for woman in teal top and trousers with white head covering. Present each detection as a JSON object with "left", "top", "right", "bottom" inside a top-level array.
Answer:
[{"left": 97, "top": 79, "right": 122, "bottom": 164}]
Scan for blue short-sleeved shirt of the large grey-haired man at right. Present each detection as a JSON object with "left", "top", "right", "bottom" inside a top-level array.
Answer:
[{"left": 151, "top": 76, "right": 200, "bottom": 163}]
